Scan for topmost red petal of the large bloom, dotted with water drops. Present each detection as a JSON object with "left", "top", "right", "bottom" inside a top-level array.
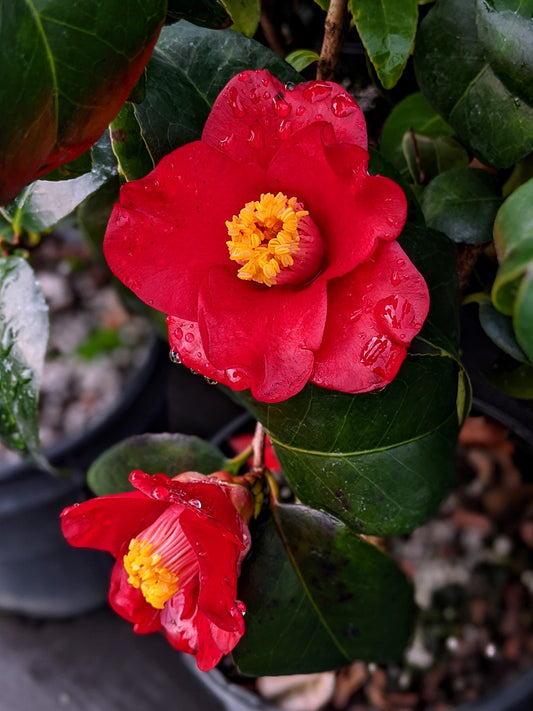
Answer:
[{"left": 202, "top": 69, "right": 367, "bottom": 168}]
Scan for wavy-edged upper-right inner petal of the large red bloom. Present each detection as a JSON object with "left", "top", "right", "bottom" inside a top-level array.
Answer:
[{"left": 268, "top": 124, "right": 407, "bottom": 278}]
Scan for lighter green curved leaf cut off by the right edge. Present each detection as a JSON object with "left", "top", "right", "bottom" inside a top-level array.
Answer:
[{"left": 491, "top": 179, "right": 533, "bottom": 316}]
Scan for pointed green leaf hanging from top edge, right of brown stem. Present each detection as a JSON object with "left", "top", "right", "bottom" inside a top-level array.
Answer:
[{"left": 351, "top": 0, "right": 418, "bottom": 89}]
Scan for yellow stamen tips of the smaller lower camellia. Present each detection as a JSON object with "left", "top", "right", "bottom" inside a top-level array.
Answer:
[{"left": 124, "top": 538, "right": 179, "bottom": 610}]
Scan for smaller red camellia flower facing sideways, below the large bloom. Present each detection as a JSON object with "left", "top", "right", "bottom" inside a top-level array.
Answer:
[{"left": 61, "top": 471, "right": 253, "bottom": 671}]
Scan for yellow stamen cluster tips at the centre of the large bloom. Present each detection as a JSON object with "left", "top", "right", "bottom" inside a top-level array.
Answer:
[{"left": 226, "top": 193, "right": 309, "bottom": 286}]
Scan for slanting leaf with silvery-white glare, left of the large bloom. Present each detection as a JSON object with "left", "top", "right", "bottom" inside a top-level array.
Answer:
[{"left": 5, "top": 132, "right": 116, "bottom": 233}]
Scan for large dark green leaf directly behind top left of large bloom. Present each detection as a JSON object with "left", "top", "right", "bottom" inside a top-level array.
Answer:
[{"left": 131, "top": 22, "right": 301, "bottom": 163}]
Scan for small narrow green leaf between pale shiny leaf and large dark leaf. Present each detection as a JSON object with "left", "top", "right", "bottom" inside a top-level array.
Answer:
[{"left": 109, "top": 101, "right": 154, "bottom": 180}]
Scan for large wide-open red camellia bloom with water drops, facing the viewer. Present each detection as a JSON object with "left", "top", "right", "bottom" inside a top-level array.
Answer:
[{"left": 104, "top": 70, "right": 429, "bottom": 402}]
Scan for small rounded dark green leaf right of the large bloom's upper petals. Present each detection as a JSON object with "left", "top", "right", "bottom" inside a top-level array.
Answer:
[{"left": 421, "top": 167, "right": 502, "bottom": 244}]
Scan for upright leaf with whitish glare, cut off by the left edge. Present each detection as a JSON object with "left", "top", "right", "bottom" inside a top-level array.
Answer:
[{"left": 0, "top": 257, "right": 48, "bottom": 466}]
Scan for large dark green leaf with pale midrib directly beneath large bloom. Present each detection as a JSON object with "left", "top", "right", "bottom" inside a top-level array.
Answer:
[{"left": 236, "top": 355, "right": 458, "bottom": 535}]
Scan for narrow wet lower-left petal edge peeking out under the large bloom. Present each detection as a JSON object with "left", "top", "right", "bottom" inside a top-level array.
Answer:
[{"left": 167, "top": 316, "right": 250, "bottom": 390}]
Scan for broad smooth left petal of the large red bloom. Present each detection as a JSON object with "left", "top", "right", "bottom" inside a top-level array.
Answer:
[{"left": 104, "top": 141, "right": 264, "bottom": 320}]
